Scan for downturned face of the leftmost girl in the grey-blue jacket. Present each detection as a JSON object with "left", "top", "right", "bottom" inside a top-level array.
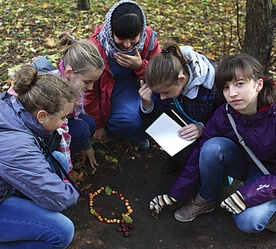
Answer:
[{"left": 41, "top": 102, "right": 74, "bottom": 132}]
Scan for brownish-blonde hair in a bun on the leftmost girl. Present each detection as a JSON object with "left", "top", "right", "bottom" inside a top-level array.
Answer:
[{"left": 13, "top": 65, "right": 76, "bottom": 116}]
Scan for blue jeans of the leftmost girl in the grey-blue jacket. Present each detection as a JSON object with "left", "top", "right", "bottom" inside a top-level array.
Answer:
[{"left": 0, "top": 151, "right": 74, "bottom": 249}]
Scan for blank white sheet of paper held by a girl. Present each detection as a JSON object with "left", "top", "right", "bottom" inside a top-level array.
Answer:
[{"left": 146, "top": 113, "right": 195, "bottom": 156}]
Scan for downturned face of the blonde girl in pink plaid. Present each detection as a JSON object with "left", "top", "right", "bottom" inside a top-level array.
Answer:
[{"left": 70, "top": 69, "right": 103, "bottom": 92}]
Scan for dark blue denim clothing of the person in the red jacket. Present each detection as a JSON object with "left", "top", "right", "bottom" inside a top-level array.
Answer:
[{"left": 105, "top": 58, "right": 148, "bottom": 141}]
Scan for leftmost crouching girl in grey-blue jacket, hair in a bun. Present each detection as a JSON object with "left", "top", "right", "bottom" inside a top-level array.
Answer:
[{"left": 0, "top": 65, "right": 79, "bottom": 249}]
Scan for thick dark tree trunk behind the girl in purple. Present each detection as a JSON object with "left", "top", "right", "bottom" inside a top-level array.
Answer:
[{"left": 243, "top": 0, "right": 275, "bottom": 73}]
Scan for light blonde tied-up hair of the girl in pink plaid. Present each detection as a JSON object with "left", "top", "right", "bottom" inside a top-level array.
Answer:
[{"left": 59, "top": 32, "right": 104, "bottom": 75}]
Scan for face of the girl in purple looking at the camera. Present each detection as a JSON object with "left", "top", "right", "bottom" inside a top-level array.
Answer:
[{"left": 223, "top": 70, "right": 263, "bottom": 116}]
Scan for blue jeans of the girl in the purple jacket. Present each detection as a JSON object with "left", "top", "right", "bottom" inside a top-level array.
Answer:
[{"left": 199, "top": 137, "right": 276, "bottom": 233}]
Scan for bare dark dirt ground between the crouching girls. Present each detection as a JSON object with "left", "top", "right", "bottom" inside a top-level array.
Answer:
[{"left": 65, "top": 141, "right": 276, "bottom": 249}]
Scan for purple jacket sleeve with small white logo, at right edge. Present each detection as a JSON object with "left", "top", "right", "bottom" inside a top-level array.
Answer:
[{"left": 238, "top": 175, "right": 276, "bottom": 208}]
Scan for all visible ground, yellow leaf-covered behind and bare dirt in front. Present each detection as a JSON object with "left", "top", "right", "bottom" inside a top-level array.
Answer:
[{"left": 0, "top": 0, "right": 276, "bottom": 249}]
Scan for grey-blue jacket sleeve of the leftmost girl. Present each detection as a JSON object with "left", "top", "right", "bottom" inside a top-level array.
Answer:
[{"left": 0, "top": 132, "right": 79, "bottom": 211}]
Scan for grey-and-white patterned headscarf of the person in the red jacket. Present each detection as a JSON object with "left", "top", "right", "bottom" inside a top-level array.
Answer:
[{"left": 99, "top": 0, "right": 146, "bottom": 57}]
